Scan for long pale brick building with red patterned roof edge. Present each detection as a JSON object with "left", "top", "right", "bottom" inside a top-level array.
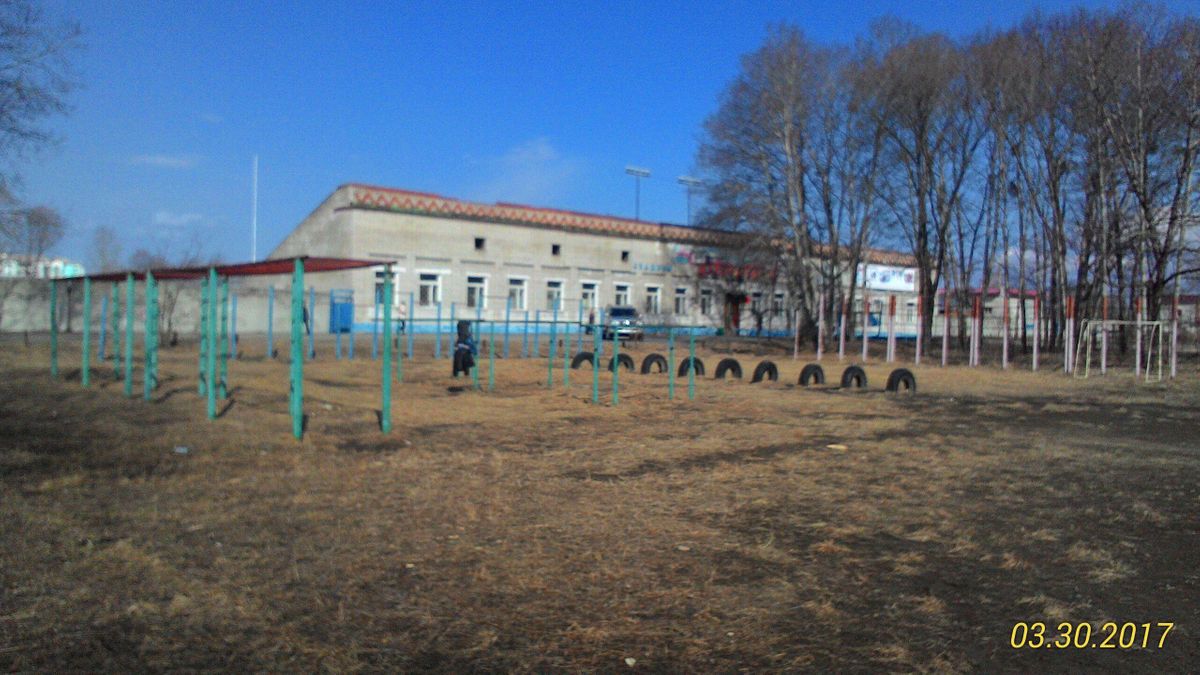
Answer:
[{"left": 270, "top": 184, "right": 911, "bottom": 329}]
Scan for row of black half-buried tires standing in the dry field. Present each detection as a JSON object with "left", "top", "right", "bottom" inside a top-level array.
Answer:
[{"left": 571, "top": 352, "right": 917, "bottom": 392}]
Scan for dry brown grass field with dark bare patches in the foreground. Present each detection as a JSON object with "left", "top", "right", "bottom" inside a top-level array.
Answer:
[{"left": 0, "top": 340, "right": 1200, "bottom": 673}]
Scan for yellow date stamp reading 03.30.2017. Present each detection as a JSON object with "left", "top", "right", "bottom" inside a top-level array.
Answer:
[{"left": 1008, "top": 621, "right": 1175, "bottom": 650}]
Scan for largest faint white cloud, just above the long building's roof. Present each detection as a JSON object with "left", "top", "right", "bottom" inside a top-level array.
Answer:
[{"left": 475, "top": 137, "right": 583, "bottom": 204}]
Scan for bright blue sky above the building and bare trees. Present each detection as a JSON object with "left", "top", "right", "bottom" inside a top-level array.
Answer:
[{"left": 28, "top": 0, "right": 1132, "bottom": 264}]
